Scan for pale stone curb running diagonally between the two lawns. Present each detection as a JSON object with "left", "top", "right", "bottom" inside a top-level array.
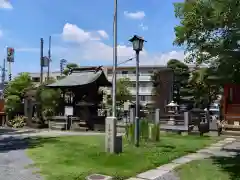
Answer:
[{"left": 128, "top": 138, "right": 236, "bottom": 180}]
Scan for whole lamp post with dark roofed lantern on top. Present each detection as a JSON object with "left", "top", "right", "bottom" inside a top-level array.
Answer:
[{"left": 129, "top": 35, "right": 146, "bottom": 147}]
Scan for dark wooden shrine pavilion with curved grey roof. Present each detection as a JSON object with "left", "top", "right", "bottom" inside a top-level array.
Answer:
[{"left": 47, "top": 67, "right": 111, "bottom": 130}]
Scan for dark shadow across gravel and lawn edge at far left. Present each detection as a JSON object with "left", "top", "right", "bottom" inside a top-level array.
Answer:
[{"left": 0, "top": 136, "right": 58, "bottom": 153}]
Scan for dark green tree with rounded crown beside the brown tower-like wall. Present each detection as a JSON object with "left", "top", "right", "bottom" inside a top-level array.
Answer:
[{"left": 167, "top": 59, "right": 190, "bottom": 104}]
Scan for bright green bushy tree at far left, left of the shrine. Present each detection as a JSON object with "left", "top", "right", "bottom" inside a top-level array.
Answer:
[{"left": 4, "top": 73, "right": 33, "bottom": 117}]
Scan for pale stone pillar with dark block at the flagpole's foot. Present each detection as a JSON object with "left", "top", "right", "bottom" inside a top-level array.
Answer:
[{"left": 105, "top": 117, "right": 122, "bottom": 153}]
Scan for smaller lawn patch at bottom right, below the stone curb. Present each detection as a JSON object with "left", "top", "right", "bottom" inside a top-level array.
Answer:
[{"left": 176, "top": 156, "right": 240, "bottom": 180}]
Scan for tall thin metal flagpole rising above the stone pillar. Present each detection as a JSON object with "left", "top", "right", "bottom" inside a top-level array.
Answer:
[{"left": 112, "top": 0, "right": 117, "bottom": 117}]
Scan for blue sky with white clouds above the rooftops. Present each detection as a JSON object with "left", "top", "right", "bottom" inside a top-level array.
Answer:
[{"left": 0, "top": 0, "right": 184, "bottom": 74}]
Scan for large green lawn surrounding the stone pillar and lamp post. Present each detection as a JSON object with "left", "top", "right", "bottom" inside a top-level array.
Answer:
[{"left": 28, "top": 135, "right": 219, "bottom": 180}]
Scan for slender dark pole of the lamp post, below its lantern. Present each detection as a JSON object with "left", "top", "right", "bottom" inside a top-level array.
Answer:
[{"left": 135, "top": 51, "right": 140, "bottom": 147}]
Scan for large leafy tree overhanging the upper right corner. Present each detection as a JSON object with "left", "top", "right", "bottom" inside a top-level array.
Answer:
[{"left": 175, "top": 0, "right": 240, "bottom": 83}]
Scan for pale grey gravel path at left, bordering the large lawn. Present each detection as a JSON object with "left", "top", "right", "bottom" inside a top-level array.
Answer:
[{"left": 0, "top": 128, "right": 106, "bottom": 180}]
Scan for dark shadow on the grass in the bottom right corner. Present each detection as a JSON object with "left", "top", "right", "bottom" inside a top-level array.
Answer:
[{"left": 212, "top": 148, "right": 240, "bottom": 180}]
